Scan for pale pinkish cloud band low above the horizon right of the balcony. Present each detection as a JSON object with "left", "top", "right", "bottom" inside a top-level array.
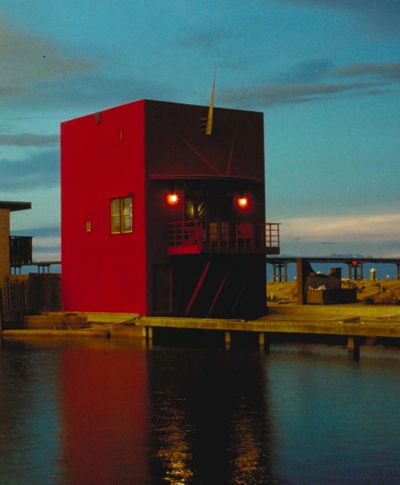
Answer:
[{"left": 282, "top": 214, "right": 400, "bottom": 243}]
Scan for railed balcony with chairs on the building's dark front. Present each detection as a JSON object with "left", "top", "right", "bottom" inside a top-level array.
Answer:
[{"left": 168, "top": 220, "right": 280, "bottom": 255}]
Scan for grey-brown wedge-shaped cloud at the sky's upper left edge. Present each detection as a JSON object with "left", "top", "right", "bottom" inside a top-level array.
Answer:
[{"left": 0, "top": 16, "right": 96, "bottom": 97}]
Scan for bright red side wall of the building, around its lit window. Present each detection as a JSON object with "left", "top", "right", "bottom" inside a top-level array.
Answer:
[{"left": 61, "top": 101, "right": 147, "bottom": 314}]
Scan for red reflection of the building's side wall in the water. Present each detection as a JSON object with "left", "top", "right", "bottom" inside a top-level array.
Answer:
[{"left": 61, "top": 347, "right": 148, "bottom": 484}]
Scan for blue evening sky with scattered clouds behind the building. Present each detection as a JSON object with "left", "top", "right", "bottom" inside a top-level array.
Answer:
[{"left": 0, "top": 0, "right": 400, "bottom": 261}]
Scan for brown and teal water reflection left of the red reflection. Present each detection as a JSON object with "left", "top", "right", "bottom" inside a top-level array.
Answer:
[{"left": 0, "top": 340, "right": 59, "bottom": 484}]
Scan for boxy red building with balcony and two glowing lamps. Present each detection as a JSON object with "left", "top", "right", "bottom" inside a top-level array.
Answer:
[{"left": 61, "top": 100, "right": 279, "bottom": 316}]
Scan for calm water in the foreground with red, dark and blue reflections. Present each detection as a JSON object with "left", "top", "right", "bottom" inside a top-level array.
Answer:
[{"left": 0, "top": 339, "right": 400, "bottom": 485}]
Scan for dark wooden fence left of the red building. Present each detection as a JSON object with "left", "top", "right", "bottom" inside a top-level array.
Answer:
[{"left": 0, "top": 273, "right": 61, "bottom": 323}]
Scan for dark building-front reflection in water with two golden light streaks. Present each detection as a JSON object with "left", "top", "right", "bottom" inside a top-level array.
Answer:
[{"left": 149, "top": 350, "right": 273, "bottom": 484}]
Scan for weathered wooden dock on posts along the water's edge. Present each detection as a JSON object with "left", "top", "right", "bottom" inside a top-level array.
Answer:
[{"left": 0, "top": 304, "right": 400, "bottom": 358}]
